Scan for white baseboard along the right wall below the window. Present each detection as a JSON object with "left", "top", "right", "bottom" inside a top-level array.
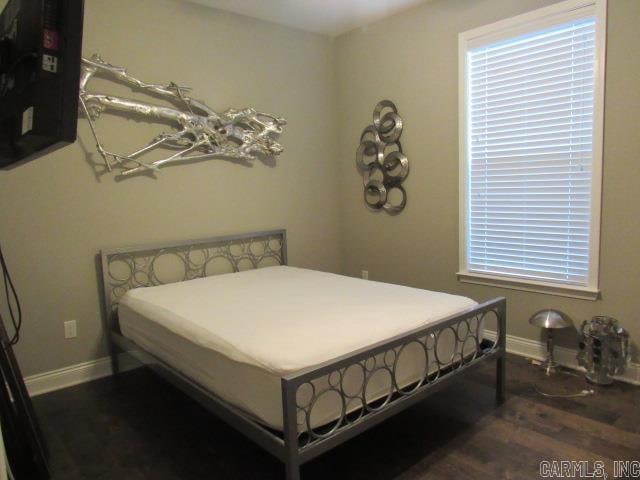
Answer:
[{"left": 485, "top": 330, "right": 640, "bottom": 385}]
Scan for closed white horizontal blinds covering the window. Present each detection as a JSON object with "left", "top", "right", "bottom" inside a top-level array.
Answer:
[{"left": 465, "top": 18, "right": 595, "bottom": 285}]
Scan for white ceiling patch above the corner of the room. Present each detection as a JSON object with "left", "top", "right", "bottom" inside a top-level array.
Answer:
[{"left": 188, "top": 0, "right": 429, "bottom": 36}]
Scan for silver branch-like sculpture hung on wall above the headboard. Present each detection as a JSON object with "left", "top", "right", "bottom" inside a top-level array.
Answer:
[{"left": 80, "top": 55, "right": 287, "bottom": 176}]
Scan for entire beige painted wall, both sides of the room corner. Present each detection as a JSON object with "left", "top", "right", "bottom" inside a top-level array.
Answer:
[{"left": 0, "top": 0, "right": 640, "bottom": 375}]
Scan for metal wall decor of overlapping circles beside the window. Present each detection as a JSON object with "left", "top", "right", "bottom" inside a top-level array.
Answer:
[{"left": 356, "top": 100, "right": 409, "bottom": 214}]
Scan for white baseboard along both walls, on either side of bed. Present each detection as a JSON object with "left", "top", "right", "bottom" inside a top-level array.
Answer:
[{"left": 24, "top": 330, "right": 640, "bottom": 397}]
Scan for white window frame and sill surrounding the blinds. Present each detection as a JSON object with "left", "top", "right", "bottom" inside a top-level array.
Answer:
[{"left": 457, "top": 0, "right": 607, "bottom": 300}]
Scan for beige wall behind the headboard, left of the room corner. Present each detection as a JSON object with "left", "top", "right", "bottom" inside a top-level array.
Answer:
[{"left": 0, "top": 0, "right": 340, "bottom": 375}]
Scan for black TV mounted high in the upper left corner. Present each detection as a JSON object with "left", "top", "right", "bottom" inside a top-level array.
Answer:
[{"left": 0, "top": 0, "right": 84, "bottom": 167}]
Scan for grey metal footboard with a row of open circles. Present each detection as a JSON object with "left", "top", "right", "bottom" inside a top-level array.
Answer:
[{"left": 282, "top": 298, "right": 506, "bottom": 480}]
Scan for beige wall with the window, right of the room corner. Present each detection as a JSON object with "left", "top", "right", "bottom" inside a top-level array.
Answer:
[{"left": 336, "top": 0, "right": 640, "bottom": 360}]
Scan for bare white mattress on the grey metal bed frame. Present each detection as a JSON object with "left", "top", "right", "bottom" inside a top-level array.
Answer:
[{"left": 118, "top": 266, "right": 476, "bottom": 430}]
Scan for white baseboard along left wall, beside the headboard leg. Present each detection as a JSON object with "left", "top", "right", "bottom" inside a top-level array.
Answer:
[{"left": 24, "top": 355, "right": 138, "bottom": 397}]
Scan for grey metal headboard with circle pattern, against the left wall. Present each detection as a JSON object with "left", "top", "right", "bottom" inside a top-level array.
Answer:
[{"left": 100, "top": 230, "right": 287, "bottom": 331}]
